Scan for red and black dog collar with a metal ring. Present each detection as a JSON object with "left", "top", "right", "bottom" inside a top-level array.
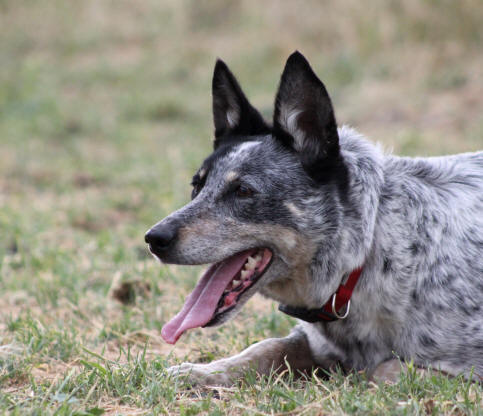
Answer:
[{"left": 278, "top": 267, "right": 362, "bottom": 323}]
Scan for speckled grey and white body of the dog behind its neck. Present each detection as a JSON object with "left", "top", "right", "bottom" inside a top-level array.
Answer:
[{"left": 352, "top": 152, "right": 483, "bottom": 375}]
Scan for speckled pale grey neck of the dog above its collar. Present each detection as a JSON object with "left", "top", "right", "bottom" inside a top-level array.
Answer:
[{"left": 304, "top": 127, "right": 384, "bottom": 309}]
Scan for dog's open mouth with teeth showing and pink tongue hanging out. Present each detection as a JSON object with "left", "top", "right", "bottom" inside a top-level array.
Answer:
[{"left": 161, "top": 248, "right": 273, "bottom": 344}]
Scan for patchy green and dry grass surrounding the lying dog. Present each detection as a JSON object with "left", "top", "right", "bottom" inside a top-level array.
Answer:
[{"left": 0, "top": 0, "right": 483, "bottom": 415}]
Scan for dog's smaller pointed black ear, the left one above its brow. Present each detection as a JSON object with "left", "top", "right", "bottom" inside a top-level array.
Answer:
[{"left": 212, "top": 59, "right": 271, "bottom": 149}]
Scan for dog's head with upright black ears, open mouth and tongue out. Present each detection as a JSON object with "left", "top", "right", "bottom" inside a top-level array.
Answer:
[{"left": 146, "top": 52, "right": 347, "bottom": 343}]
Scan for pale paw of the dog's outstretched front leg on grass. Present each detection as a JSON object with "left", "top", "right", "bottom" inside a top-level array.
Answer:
[{"left": 167, "top": 363, "right": 233, "bottom": 386}]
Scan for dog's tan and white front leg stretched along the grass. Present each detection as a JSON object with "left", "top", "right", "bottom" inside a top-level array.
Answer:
[{"left": 168, "top": 328, "right": 316, "bottom": 386}]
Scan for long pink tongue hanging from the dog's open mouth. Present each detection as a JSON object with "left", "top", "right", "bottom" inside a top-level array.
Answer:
[{"left": 161, "top": 250, "right": 255, "bottom": 344}]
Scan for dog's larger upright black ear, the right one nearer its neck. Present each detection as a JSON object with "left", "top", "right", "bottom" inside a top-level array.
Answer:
[{"left": 273, "top": 52, "right": 339, "bottom": 180}]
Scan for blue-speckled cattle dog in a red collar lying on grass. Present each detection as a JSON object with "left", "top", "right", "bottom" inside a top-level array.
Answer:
[{"left": 145, "top": 52, "right": 483, "bottom": 385}]
